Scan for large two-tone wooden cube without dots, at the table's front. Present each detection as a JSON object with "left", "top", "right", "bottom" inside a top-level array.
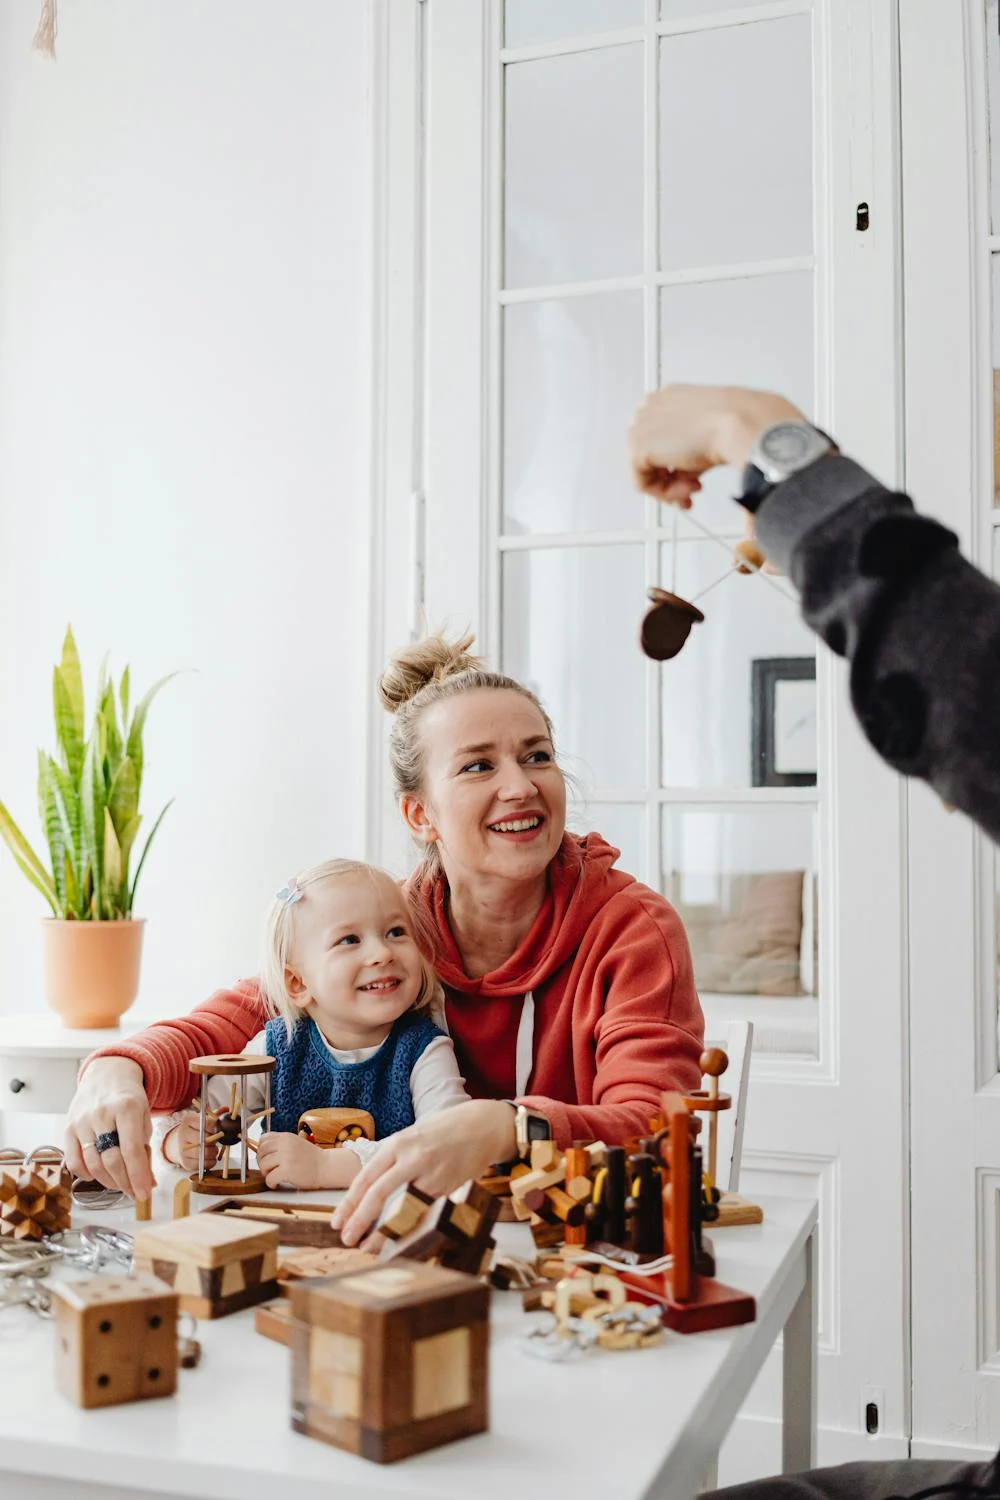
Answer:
[{"left": 291, "top": 1262, "right": 489, "bottom": 1464}]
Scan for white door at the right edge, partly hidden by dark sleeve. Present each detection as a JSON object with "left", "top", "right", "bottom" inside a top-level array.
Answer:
[{"left": 900, "top": 0, "right": 1000, "bottom": 1457}]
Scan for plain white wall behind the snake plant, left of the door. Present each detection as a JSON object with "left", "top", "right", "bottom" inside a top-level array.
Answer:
[{"left": 0, "top": 0, "right": 369, "bottom": 1014}]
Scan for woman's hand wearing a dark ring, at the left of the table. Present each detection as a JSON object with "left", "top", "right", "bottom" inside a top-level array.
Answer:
[{"left": 64, "top": 1058, "right": 156, "bottom": 1199}]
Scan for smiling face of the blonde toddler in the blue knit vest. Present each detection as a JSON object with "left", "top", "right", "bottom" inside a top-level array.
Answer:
[{"left": 288, "top": 873, "right": 421, "bottom": 1031}]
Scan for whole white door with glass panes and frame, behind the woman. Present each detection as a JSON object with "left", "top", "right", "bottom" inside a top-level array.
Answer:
[{"left": 373, "top": 0, "right": 907, "bottom": 1473}]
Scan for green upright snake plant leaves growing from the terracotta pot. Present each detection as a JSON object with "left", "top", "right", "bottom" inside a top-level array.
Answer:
[{"left": 0, "top": 629, "right": 177, "bottom": 921}]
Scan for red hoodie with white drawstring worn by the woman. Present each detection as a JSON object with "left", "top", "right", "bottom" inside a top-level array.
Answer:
[{"left": 94, "top": 834, "right": 705, "bottom": 1145}]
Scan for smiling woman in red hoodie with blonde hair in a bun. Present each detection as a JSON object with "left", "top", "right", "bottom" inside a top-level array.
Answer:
[{"left": 67, "top": 636, "right": 703, "bottom": 1244}]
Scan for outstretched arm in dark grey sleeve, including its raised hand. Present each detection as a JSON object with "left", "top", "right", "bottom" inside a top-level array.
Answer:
[{"left": 628, "top": 386, "right": 1000, "bottom": 842}]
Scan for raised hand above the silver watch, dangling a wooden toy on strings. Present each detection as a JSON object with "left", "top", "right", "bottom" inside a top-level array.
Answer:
[{"left": 628, "top": 386, "right": 805, "bottom": 510}]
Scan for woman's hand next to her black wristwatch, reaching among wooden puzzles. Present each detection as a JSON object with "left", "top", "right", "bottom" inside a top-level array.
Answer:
[{"left": 333, "top": 1100, "right": 516, "bottom": 1245}]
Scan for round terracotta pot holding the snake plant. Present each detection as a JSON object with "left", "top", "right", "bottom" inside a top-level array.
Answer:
[{"left": 42, "top": 917, "right": 145, "bottom": 1029}]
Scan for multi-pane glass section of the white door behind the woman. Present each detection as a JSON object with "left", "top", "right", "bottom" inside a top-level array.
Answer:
[{"left": 493, "top": 0, "right": 820, "bottom": 1058}]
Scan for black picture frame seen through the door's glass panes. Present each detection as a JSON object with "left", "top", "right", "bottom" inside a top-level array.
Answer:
[{"left": 750, "top": 657, "right": 817, "bottom": 786}]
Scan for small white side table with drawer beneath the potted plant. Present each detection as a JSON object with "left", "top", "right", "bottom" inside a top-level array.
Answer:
[{"left": 0, "top": 1014, "right": 145, "bottom": 1145}]
